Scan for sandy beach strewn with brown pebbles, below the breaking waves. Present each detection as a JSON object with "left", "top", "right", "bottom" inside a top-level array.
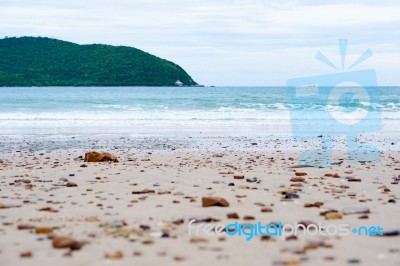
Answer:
[{"left": 0, "top": 137, "right": 400, "bottom": 265}]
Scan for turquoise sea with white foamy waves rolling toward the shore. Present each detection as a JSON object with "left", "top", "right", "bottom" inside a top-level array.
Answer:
[{"left": 0, "top": 87, "right": 400, "bottom": 136}]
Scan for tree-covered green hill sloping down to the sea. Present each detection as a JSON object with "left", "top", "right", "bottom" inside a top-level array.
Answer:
[{"left": 0, "top": 37, "right": 197, "bottom": 86}]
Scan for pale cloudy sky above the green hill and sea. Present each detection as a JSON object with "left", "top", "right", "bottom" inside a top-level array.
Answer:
[{"left": 0, "top": 0, "right": 400, "bottom": 86}]
